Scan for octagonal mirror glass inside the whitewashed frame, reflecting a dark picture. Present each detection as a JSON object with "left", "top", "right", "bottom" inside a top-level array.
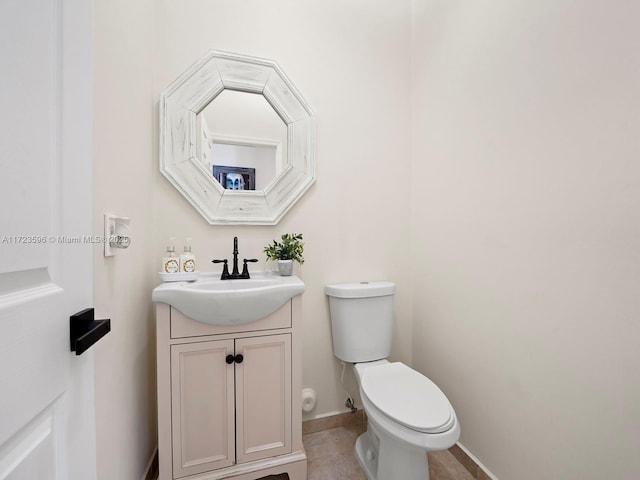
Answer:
[{"left": 196, "top": 89, "right": 287, "bottom": 191}]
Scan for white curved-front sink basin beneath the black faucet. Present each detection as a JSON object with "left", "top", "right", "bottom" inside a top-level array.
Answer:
[{"left": 151, "top": 272, "right": 304, "bottom": 325}]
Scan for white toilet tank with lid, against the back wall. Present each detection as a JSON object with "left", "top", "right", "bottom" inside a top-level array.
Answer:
[{"left": 324, "top": 282, "right": 396, "bottom": 363}]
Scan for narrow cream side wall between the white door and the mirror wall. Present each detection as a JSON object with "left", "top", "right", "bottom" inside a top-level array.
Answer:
[{"left": 93, "top": 0, "right": 156, "bottom": 480}]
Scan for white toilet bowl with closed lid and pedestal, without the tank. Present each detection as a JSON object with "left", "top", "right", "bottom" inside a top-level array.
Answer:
[{"left": 354, "top": 360, "right": 460, "bottom": 480}]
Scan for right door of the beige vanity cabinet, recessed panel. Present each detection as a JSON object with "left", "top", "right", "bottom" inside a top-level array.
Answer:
[{"left": 235, "top": 334, "right": 291, "bottom": 463}]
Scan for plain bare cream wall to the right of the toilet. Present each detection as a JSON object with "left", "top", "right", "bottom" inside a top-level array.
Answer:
[{"left": 412, "top": 0, "right": 640, "bottom": 480}]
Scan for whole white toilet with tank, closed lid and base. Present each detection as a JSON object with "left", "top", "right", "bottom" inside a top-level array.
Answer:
[{"left": 325, "top": 282, "right": 460, "bottom": 480}]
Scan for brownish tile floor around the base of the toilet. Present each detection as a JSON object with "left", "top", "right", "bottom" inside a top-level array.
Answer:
[{"left": 265, "top": 416, "right": 475, "bottom": 480}]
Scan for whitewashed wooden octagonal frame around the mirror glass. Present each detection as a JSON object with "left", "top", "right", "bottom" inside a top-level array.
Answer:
[{"left": 159, "top": 50, "right": 316, "bottom": 225}]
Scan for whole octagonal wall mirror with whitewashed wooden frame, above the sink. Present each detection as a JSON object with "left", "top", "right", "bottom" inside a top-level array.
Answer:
[{"left": 160, "top": 51, "right": 315, "bottom": 225}]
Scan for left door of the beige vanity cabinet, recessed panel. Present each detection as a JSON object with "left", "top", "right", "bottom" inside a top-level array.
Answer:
[{"left": 171, "top": 340, "right": 235, "bottom": 478}]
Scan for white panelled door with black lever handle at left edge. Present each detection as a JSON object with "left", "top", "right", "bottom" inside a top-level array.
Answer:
[{"left": 0, "top": 0, "right": 96, "bottom": 480}]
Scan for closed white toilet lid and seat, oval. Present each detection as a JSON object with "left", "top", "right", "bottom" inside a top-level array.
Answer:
[{"left": 360, "top": 362, "right": 455, "bottom": 434}]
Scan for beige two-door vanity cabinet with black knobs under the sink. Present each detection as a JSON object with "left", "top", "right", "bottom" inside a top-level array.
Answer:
[{"left": 157, "top": 296, "right": 307, "bottom": 480}]
